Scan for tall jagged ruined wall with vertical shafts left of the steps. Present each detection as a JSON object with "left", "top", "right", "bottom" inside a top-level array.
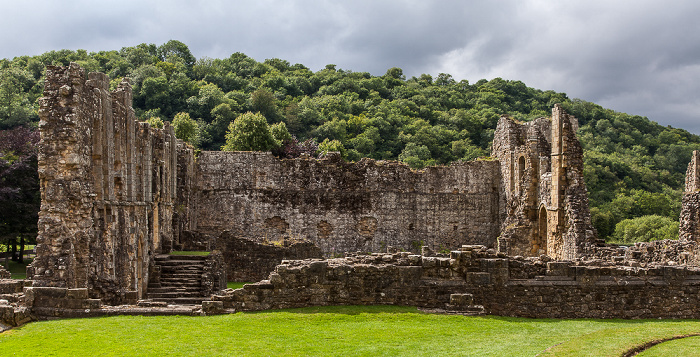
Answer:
[{"left": 28, "top": 63, "right": 189, "bottom": 302}]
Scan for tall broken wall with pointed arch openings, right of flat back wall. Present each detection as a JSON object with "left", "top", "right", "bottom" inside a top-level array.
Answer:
[{"left": 492, "top": 104, "right": 596, "bottom": 259}]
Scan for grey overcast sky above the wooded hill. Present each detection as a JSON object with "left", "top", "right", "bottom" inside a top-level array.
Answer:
[{"left": 0, "top": 0, "right": 700, "bottom": 134}]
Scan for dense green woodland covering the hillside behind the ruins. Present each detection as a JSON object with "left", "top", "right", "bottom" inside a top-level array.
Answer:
[{"left": 0, "top": 40, "right": 700, "bottom": 239}]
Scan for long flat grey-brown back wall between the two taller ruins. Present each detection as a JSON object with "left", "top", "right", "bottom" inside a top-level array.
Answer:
[{"left": 195, "top": 152, "right": 503, "bottom": 255}]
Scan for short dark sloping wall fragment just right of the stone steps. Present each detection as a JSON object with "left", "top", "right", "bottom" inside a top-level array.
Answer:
[{"left": 218, "top": 231, "right": 323, "bottom": 282}]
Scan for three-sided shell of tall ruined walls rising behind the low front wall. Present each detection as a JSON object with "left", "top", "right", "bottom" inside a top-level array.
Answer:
[{"left": 29, "top": 64, "right": 595, "bottom": 303}]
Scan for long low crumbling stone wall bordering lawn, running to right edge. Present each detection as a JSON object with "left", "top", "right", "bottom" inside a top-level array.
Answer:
[{"left": 213, "top": 246, "right": 700, "bottom": 318}]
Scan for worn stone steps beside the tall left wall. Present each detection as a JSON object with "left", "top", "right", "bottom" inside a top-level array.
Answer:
[{"left": 147, "top": 255, "right": 209, "bottom": 305}]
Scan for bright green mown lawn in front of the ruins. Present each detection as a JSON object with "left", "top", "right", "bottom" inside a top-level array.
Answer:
[{"left": 0, "top": 306, "right": 700, "bottom": 356}]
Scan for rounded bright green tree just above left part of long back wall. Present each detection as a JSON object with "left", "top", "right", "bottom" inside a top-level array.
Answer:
[{"left": 221, "top": 112, "right": 277, "bottom": 151}]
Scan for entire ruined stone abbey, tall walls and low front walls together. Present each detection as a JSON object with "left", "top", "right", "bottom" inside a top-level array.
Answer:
[{"left": 0, "top": 64, "right": 700, "bottom": 325}]
